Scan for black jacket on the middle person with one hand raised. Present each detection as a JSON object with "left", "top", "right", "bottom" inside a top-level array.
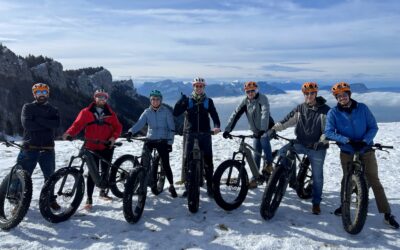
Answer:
[{"left": 173, "top": 96, "right": 221, "bottom": 132}]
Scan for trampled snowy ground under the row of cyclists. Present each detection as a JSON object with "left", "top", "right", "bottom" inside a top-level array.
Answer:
[{"left": 0, "top": 123, "right": 400, "bottom": 249}]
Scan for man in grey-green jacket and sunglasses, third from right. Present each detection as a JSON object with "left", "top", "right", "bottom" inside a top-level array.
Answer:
[{"left": 222, "top": 81, "right": 272, "bottom": 188}]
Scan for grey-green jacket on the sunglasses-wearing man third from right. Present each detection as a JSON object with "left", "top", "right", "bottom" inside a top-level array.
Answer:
[{"left": 225, "top": 93, "right": 270, "bottom": 133}]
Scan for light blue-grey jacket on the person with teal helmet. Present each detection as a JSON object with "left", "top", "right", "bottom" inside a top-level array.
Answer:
[{"left": 129, "top": 106, "right": 175, "bottom": 145}]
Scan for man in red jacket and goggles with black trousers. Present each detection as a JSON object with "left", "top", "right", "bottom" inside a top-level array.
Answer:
[{"left": 63, "top": 90, "right": 122, "bottom": 210}]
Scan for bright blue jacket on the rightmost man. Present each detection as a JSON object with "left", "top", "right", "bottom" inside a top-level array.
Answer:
[{"left": 325, "top": 100, "right": 378, "bottom": 154}]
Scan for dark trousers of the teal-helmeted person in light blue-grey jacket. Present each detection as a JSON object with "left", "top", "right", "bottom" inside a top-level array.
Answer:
[{"left": 142, "top": 141, "right": 174, "bottom": 185}]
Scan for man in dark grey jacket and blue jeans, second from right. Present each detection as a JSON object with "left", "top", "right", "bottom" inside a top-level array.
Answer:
[{"left": 268, "top": 82, "right": 329, "bottom": 215}]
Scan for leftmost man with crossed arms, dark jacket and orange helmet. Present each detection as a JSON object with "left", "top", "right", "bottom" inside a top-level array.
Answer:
[{"left": 17, "top": 83, "right": 60, "bottom": 210}]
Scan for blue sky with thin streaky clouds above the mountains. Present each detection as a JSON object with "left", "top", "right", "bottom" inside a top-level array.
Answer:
[{"left": 0, "top": 0, "right": 400, "bottom": 86}]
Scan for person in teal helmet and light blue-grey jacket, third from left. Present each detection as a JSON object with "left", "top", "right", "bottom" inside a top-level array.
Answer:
[{"left": 128, "top": 90, "right": 177, "bottom": 198}]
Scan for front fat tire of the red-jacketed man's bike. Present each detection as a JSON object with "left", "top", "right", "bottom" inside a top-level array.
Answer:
[{"left": 39, "top": 167, "right": 85, "bottom": 223}]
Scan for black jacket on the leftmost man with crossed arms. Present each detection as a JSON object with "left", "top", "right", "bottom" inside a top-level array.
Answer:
[{"left": 21, "top": 101, "right": 60, "bottom": 147}]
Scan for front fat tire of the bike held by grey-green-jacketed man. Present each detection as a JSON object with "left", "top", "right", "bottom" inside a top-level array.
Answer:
[{"left": 213, "top": 160, "right": 249, "bottom": 211}]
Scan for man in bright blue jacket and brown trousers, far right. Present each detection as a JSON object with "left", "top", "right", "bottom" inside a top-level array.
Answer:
[{"left": 325, "top": 82, "right": 399, "bottom": 229}]
